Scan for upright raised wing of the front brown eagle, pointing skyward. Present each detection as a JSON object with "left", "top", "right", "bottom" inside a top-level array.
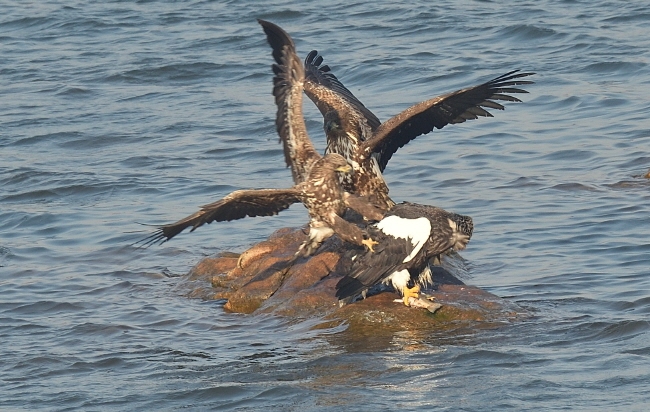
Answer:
[{"left": 258, "top": 20, "right": 320, "bottom": 184}]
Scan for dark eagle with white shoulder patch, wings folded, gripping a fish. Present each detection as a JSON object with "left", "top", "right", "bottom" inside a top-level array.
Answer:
[{"left": 336, "top": 202, "right": 474, "bottom": 306}]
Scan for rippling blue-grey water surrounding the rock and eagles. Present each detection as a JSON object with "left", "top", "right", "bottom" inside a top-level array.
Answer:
[{"left": 0, "top": 0, "right": 650, "bottom": 411}]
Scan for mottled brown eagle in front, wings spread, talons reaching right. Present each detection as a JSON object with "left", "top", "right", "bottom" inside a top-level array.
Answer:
[{"left": 136, "top": 20, "right": 383, "bottom": 256}]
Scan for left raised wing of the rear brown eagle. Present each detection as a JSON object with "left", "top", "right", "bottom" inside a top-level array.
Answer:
[{"left": 305, "top": 50, "right": 381, "bottom": 135}]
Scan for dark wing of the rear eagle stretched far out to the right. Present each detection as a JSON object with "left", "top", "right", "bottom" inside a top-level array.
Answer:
[{"left": 364, "top": 70, "right": 534, "bottom": 171}]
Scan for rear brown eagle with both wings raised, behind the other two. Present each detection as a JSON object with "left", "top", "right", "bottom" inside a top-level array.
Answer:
[{"left": 304, "top": 50, "right": 534, "bottom": 210}]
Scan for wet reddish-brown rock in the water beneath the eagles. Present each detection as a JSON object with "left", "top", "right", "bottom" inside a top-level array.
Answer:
[{"left": 180, "top": 229, "right": 522, "bottom": 339}]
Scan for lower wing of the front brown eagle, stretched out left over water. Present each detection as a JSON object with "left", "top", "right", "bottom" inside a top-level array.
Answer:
[{"left": 137, "top": 188, "right": 300, "bottom": 246}]
